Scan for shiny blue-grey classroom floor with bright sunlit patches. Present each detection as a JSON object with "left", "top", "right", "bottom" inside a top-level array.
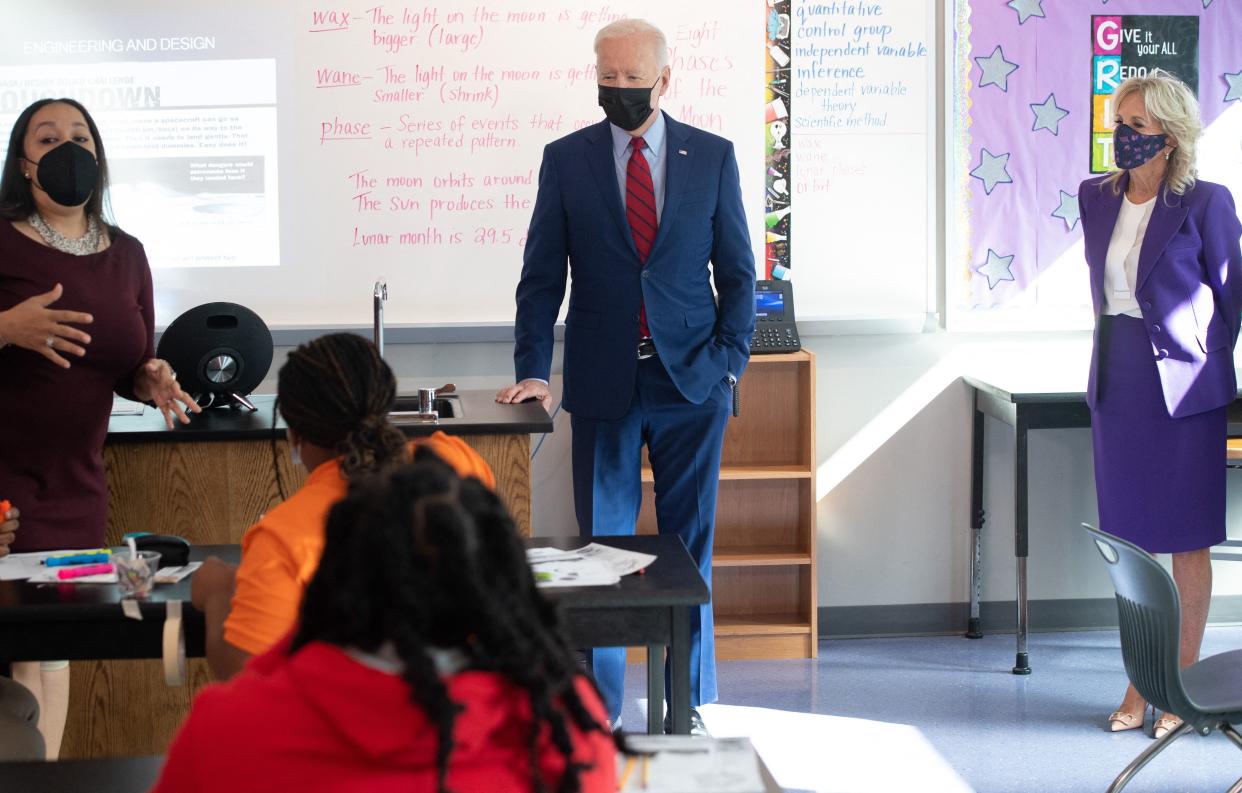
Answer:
[{"left": 622, "top": 626, "right": 1242, "bottom": 793}]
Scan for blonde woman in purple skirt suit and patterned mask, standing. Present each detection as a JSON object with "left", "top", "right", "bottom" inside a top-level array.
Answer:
[{"left": 1078, "top": 70, "right": 1242, "bottom": 737}]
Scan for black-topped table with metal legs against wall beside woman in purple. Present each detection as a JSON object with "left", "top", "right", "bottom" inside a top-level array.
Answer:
[{"left": 963, "top": 365, "right": 1242, "bottom": 675}]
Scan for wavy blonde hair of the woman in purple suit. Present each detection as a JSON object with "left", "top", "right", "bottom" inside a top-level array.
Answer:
[{"left": 1108, "top": 68, "right": 1203, "bottom": 195}]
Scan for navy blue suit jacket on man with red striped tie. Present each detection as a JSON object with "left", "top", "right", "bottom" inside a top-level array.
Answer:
[{"left": 514, "top": 116, "right": 755, "bottom": 420}]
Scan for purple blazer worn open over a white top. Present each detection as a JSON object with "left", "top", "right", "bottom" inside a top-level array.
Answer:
[{"left": 1078, "top": 174, "right": 1242, "bottom": 419}]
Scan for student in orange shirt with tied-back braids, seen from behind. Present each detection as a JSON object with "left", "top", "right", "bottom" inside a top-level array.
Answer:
[{"left": 191, "top": 333, "right": 496, "bottom": 680}]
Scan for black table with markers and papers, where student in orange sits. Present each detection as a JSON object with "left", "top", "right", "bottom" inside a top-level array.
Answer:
[{"left": 0, "top": 536, "right": 710, "bottom": 733}]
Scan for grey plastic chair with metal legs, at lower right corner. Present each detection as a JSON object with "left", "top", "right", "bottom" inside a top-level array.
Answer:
[{"left": 1083, "top": 523, "right": 1242, "bottom": 793}]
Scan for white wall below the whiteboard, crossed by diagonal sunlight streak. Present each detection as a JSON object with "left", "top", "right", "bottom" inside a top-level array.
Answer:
[{"left": 261, "top": 332, "right": 1242, "bottom": 607}]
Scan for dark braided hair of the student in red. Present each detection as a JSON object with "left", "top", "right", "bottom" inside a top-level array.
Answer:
[{"left": 289, "top": 459, "right": 607, "bottom": 793}]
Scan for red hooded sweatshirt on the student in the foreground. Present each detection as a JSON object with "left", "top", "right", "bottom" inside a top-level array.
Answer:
[{"left": 154, "top": 641, "right": 616, "bottom": 793}]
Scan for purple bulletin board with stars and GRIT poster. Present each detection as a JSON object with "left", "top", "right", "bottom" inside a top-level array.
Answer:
[{"left": 945, "top": 0, "right": 1242, "bottom": 331}]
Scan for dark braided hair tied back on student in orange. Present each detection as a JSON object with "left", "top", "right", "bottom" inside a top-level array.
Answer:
[{"left": 272, "top": 333, "right": 406, "bottom": 497}]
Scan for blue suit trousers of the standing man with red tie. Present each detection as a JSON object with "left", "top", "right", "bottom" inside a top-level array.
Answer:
[{"left": 571, "top": 358, "right": 732, "bottom": 721}]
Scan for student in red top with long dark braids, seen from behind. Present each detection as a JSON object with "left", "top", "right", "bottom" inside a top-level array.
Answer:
[{"left": 154, "top": 455, "right": 616, "bottom": 793}]
